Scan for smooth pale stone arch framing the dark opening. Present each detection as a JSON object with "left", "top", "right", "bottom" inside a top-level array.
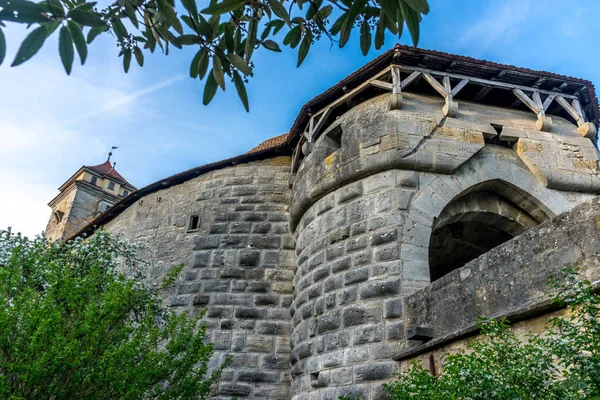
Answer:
[{"left": 401, "top": 146, "right": 572, "bottom": 293}]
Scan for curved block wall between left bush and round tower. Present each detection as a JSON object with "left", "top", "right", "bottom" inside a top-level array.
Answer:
[{"left": 105, "top": 157, "right": 294, "bottom": 399}]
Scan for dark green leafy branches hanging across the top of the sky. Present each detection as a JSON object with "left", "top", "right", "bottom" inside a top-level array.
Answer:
[{"left": 0, "top": 0, "right": 429, "bottom": 111}]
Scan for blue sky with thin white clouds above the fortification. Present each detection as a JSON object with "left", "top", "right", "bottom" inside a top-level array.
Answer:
[{"left": 0, "top": 0, "right": 600, "bottom": 236}]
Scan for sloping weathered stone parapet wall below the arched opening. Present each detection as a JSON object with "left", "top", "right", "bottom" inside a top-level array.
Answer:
[{"left": 399, "top": 197, "right": 600, "bottom": 368}]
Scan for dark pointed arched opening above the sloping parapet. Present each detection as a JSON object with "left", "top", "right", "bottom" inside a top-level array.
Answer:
[{"left": 429, "top": 180, "right": 550, "bottom": 282}]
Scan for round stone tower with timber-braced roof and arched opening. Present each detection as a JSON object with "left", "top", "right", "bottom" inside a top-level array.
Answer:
[{"left": 290, "top": 46, "right": 600, "bottom": 399}]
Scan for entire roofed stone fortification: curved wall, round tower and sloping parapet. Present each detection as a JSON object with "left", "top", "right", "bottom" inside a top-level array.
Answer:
[{"left": 63, "top": 46, "right": 600, "bottom": 400}]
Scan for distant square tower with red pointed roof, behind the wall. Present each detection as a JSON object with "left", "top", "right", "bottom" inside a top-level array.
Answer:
[{"left": 45, "top": 160, "right": 135, "bottom": 240}]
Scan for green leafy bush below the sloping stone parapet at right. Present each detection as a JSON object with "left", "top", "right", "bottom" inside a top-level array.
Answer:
[{"left": 384, "top": 269, "right": 600, "bottom": 400}]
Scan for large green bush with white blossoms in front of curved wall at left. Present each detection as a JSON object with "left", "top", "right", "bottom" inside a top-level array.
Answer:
[{"left": 0, "top": 230, "right": 222, "bottom": 400}]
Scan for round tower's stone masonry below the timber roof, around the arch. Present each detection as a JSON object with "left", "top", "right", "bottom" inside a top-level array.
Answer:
[{"left": 290, "top": 94, "right": 599, "bottom": 400}]
